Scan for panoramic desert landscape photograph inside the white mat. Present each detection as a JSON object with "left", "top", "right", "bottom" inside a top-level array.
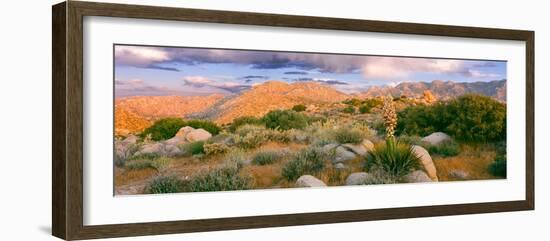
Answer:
[{"left": 111, "top": 44, "right": 507, "bottom": 195}]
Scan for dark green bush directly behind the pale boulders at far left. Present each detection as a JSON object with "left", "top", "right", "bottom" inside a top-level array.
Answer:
[{"left": 140, "top": 118, "right": 186, "bottom": 141}]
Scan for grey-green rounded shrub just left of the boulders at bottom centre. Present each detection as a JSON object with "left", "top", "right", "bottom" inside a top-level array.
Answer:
[{"left": 281, "top": 147, "right": 328, "bottom": 181}]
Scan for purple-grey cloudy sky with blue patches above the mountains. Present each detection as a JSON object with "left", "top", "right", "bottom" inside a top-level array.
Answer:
[{"left": 114, "top": 45, "right": 506, "bottom": 97}]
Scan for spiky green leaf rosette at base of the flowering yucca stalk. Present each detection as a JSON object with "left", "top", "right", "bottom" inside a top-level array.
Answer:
[{"left": 365, "top": 139, "right": 420, "bottom": 177}]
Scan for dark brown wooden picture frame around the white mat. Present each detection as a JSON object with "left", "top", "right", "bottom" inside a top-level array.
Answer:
[{"left": 52, "top": 1, "right": 535, "bottom": 240}]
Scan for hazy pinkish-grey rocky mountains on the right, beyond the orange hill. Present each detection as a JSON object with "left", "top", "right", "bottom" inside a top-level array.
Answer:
[{"left": 358, "top": 80, "right": 506, "bottom": 102}]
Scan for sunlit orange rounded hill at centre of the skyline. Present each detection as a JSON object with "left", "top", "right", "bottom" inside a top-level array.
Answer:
[{"left": 209, "top": 81, "right": 349, "bottom": 124}]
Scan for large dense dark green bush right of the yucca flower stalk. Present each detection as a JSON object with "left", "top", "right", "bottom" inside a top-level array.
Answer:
[{"left": 397, "top": 94, "right": 506, "bottom": 142}]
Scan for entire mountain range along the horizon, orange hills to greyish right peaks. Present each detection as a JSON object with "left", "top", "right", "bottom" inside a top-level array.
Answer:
[{"left": 115, "top": 80, "right": 506, "bottom": 134}]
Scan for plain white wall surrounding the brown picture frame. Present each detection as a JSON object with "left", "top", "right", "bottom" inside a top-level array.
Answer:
[{"left": 0, "top": 0, "right": 550, "bottom": 241}]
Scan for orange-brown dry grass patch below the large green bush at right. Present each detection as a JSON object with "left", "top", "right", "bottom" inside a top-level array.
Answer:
[{"left": 434, "top": 145, "right": 504, "bottom": 181}]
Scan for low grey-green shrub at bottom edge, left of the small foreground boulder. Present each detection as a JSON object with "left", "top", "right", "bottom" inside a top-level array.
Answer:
[{"left": 183, "top": 164, "right": 252, "bottom": 192}]
